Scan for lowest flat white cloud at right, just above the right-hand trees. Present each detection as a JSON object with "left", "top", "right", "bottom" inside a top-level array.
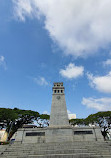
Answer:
[{"left": 82, "top": 98, "right": 111, "bottom": 111}]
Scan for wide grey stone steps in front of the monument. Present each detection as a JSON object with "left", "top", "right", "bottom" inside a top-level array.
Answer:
[{"left": 0, "top": 141, "right": 111, "bottom": 158}]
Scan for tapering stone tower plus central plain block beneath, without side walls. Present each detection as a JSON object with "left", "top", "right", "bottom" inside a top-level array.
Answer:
[{"left": 46, "top": 82, "right": 73, "bottom": 142}]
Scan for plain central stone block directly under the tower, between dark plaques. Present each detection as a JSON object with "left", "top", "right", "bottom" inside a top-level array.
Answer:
[{"left": 46, "top": 126, "right": 73, "bottom": 143}]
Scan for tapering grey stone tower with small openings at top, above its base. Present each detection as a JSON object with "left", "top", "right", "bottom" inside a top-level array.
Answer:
[{"left": 49, "top": 82, "right": 69, "bottom": 127}]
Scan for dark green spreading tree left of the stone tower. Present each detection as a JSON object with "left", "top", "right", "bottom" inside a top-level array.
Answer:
[{"left": 0, "top": 108, "right": 49, "bottom": 139}]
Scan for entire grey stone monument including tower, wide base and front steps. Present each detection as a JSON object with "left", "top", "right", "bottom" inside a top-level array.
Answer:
[{"left": 1, "top": 82, "right": 111, "bottom": 158}]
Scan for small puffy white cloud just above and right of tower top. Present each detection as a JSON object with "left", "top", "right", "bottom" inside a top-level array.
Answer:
[{"left": 59, "top": 63, "right": 84, "bottom": 79}]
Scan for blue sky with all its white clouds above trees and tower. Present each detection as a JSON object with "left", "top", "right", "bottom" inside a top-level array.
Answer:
[{"left": 0, "top": 0, "right": 111, "bottom": 118}]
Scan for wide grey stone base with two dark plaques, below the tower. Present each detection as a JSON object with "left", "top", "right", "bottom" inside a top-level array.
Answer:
[{"left": 12, "top": 126, "right": 104, "bottom": 144}]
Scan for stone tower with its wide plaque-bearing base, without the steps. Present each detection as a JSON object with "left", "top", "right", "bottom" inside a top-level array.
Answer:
[{"left": 14, "top": 82, "right": 103, "bottom": 144}]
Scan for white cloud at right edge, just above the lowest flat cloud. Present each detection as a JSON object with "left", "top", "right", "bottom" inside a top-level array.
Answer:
[{"left": 87, "top": 72, "right": 111, "bottom": 93}]
